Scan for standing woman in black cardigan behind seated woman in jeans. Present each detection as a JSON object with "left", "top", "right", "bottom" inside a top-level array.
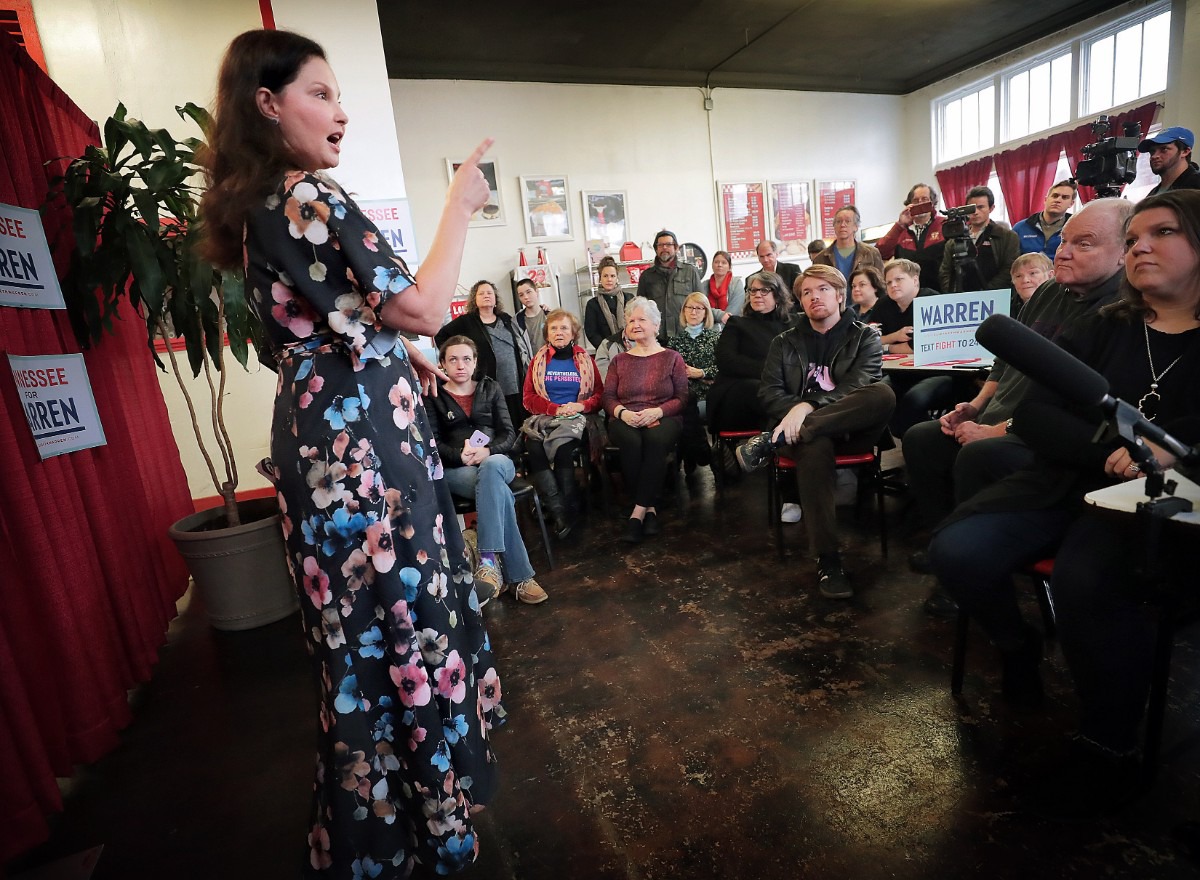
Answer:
[{"left": 433, "top": 281, "right": 533, "bottom": 425}]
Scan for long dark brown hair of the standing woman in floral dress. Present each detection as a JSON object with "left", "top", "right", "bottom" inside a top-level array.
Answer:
[{"left": 199, "top": 30, "right": 325, "bottom": 269}]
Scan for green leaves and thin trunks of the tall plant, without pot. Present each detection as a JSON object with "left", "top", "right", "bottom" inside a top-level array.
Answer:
[{"left": 48, "top": 103, "right": 262, "bottom": 526}]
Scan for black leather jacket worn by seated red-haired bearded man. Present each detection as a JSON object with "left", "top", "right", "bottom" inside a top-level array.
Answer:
[{"left": 758, "top": 310, "right": 883, "bottom": 423}]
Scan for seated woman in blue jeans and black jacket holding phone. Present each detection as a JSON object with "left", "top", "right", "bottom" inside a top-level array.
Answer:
[{"left": 425, "top": 336, "right": 547, "bottom": 605}]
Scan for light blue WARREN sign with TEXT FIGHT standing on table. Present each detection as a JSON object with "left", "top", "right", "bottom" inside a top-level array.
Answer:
[{"left": 912, "top": 291, "right": 1012, "bottom": 366}]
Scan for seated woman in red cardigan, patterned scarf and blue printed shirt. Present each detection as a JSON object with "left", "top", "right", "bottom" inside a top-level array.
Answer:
[{"left": 521, "top": 309, "right": 604, "bottom": 538}]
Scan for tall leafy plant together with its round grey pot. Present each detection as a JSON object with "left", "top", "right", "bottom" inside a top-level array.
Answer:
[{"left": 50, "top": 103, "right": 295, "bottom": 629}]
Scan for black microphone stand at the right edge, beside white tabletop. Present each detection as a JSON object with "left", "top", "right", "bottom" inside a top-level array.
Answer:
[{"left": 1100, "top": 399, "right": 1196, "bottom": 788}]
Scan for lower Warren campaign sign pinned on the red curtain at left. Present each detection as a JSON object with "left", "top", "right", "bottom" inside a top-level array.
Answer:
[{"left": 8, "top": 354, "right": 107, "bottom": 460}]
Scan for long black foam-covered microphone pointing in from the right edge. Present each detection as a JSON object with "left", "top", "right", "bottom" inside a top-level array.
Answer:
[{"left": 976, "top": 315, "right": 1200, "bottom": 462}]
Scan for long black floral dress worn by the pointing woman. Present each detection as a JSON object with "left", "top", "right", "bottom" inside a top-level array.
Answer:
[{"left": 246, "top": 172, "right": 504, "bottom": 880}]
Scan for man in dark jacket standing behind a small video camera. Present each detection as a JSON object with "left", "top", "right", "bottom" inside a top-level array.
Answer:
[{"left": 937, "top": 186, "right": 1021, "bottom": 293}]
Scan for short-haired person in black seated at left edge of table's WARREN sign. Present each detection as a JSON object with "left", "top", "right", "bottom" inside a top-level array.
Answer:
[{"left": 871, "top": 259, "right": 954, "bottom": 437}]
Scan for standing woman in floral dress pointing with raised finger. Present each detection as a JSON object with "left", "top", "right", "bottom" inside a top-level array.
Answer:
[{"left": 202, "top": 30, "right": 504, "bottom": 880}]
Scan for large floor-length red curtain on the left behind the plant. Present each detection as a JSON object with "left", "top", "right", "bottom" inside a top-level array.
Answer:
[{"left": 0, "top": 32, "right": 192, "bottom": 861}]
